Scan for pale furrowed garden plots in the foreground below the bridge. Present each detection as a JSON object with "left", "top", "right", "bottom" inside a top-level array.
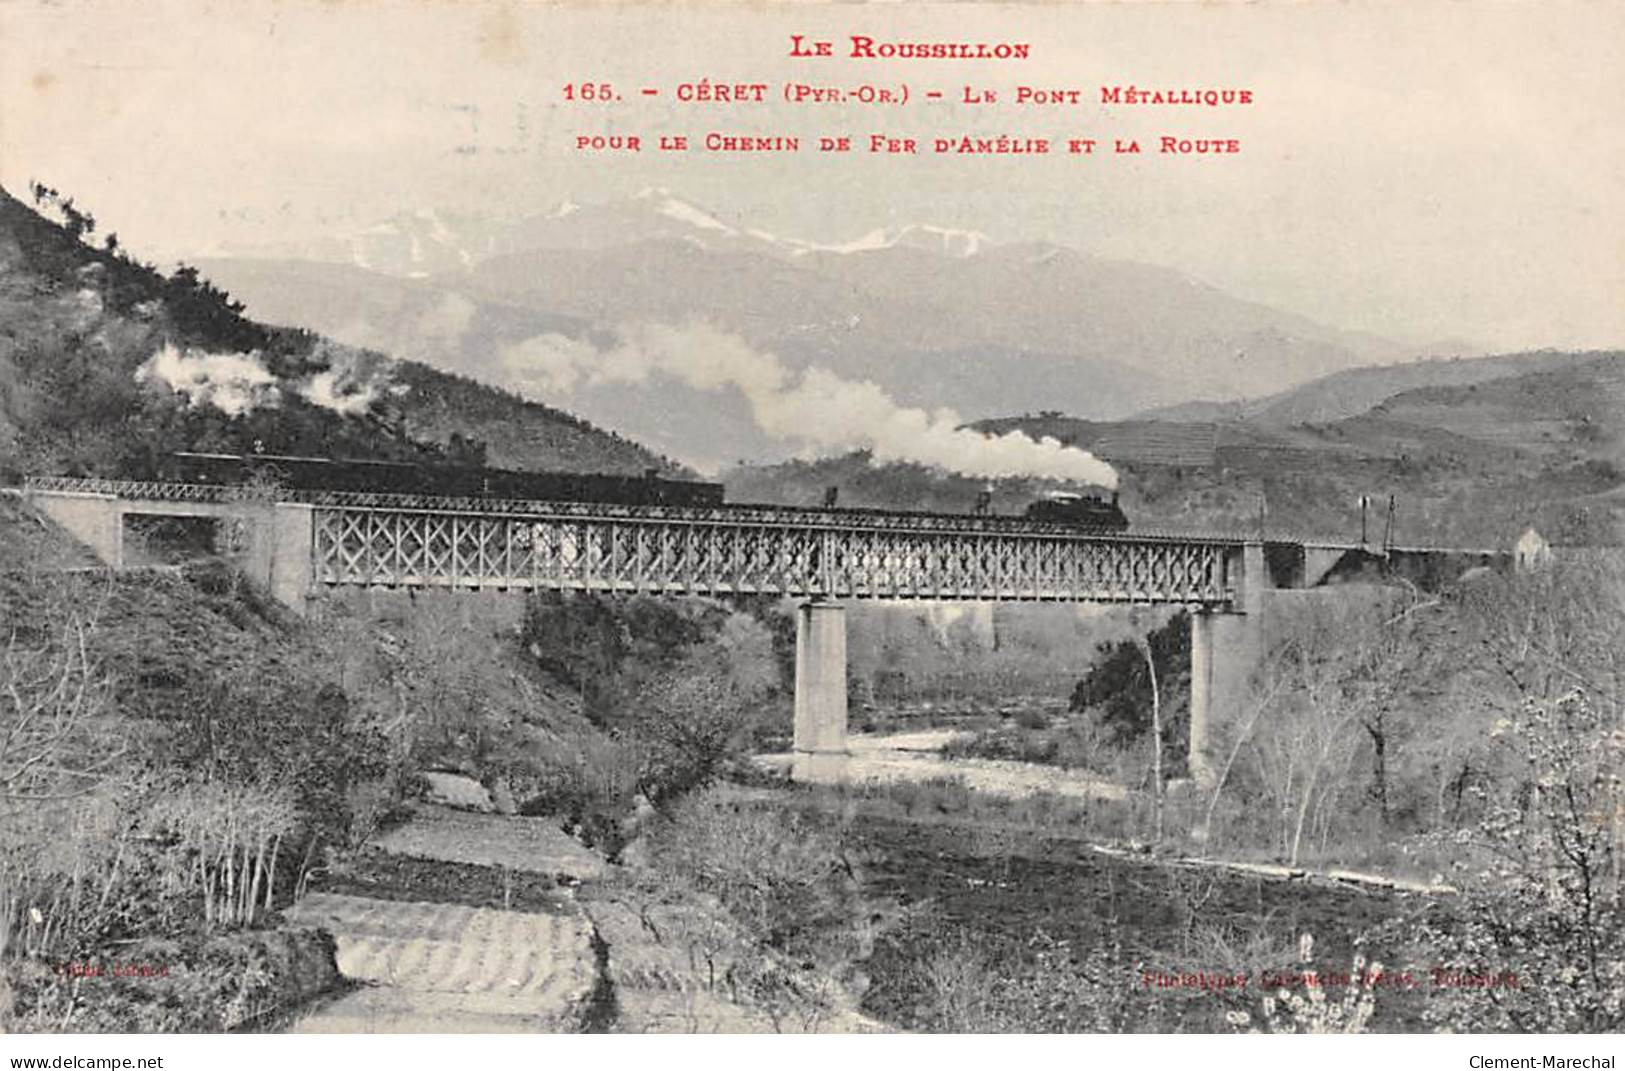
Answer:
[{"left": 288, "top": 808, "right": 603, "bottom": 1034}]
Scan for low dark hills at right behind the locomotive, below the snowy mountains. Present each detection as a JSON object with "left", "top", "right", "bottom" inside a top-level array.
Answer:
[{"left": 723, "top": 351, "right": 1625, "bottom": 549}]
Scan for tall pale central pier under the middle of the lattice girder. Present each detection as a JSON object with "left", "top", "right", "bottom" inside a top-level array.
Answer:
[{"left": 791, "top": 600, "right": 847, "bottom": 780}]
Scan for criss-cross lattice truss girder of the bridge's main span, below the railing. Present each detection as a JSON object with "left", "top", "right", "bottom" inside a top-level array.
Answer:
[{"left": 314, "top": 507, "right": 1233, "bottom": 605}]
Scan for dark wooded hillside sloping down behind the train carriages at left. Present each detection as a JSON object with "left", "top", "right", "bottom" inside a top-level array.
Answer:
[{"left": 0, "top": 187, "right": 678, "bottom": 479}]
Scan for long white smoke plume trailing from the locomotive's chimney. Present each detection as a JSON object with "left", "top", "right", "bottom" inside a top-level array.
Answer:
[{"left": 501, "top": 323, "right": 1118, "bottom": 488}]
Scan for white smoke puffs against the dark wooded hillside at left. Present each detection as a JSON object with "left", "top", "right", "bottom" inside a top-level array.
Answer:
[{"left": 135, "top": 343, "right": 388, "bottom": 416}]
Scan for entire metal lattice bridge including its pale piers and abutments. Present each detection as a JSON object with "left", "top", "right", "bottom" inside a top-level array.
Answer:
[{"left": 24, "top": 478, "right": 1485, "bottom": 777}]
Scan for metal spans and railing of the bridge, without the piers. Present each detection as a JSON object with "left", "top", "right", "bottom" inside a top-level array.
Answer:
[{"left": 19, "top": 478, "right": 1242, "bottom": 608}]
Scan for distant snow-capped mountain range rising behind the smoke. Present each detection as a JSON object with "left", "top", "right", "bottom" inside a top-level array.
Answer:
[{"left": 200, "top": 189, "right": 1443, "bottom": 474}]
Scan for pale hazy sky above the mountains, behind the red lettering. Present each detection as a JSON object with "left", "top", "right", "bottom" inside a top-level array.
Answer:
[{"left": 0, "top": 0, "right": 1625, "bottom": 348}]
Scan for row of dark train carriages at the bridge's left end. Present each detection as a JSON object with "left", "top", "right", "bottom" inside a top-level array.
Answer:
[{"left": 158, "top": 453, "right": 722, "bottom": 505}]
